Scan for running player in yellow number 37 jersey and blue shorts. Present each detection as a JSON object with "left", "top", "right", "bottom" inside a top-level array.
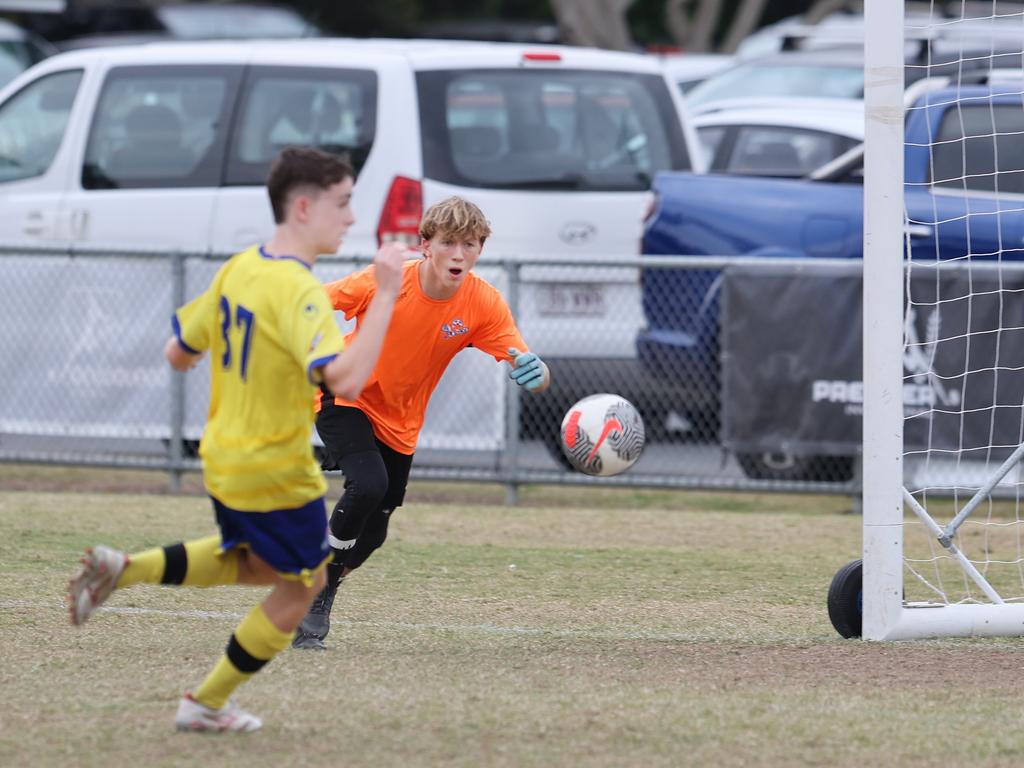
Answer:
[{"left": 69, "top": 147, "right": 408, "bottom": 731}]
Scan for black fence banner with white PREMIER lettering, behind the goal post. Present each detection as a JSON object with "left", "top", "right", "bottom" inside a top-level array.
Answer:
[{"left": 721, "top": 263, "right": 1024, "bottom": 459}]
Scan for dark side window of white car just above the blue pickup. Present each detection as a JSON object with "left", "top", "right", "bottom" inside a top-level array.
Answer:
[{"left": 716, "top": 125, "right": 853, "bottom": 176}]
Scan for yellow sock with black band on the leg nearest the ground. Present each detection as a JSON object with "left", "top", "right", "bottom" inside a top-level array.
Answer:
[{"left": 193, "top": 605, "right": 295, "bottom": 710}]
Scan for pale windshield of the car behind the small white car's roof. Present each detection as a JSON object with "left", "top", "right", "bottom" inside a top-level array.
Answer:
[{"left": 686, "top": 63, "right": 864, "bottom": 108}]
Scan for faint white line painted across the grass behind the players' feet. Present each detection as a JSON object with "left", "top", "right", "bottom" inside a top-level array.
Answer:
[{"left": 0, "top": 600, "right": 697, "bottom": 641}]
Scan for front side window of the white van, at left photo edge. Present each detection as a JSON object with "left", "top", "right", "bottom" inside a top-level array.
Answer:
[{"left": 0, "top": 70, "right": 82, "bottom": 182}]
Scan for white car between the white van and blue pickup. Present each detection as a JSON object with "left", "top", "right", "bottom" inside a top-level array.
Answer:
[{"left": 691, "top": 98, "right": 864, "bottom": 177}]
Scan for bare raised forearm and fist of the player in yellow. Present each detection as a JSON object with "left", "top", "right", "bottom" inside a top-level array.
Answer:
[{"left": 321, "top": 243, "right": 409, "bottom": 400}]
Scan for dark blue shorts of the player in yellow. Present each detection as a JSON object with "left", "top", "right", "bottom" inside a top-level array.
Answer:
[{"left": 210, "top": 496, "right": 331, "bottom": 586}]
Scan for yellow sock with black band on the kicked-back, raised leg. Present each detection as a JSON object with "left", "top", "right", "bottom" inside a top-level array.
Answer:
[{"left": 118, "top": 535, "right": 239, "bottom": 588}]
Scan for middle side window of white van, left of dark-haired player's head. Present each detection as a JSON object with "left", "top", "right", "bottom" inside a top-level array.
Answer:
[{"left": 82, "top": 66, "right": 241, "bottom": 189}]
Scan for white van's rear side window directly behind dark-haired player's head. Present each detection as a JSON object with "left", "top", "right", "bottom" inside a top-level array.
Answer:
[{"left": 226, "top": 67, "right": 377, "bottom": 185}]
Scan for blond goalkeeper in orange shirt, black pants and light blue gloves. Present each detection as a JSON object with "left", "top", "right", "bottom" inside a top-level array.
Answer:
[{"left": 293, "top": 198, "right": 550, "bottom": 648}]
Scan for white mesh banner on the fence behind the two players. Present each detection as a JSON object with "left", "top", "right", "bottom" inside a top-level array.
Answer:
[{"left": 0, "top": 256, "right": 506, "bottom": 450}]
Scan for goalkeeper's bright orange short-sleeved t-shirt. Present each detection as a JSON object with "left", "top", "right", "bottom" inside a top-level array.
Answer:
[{"left": 316, "top": 259, "right": 527, "bottom": 454}]
